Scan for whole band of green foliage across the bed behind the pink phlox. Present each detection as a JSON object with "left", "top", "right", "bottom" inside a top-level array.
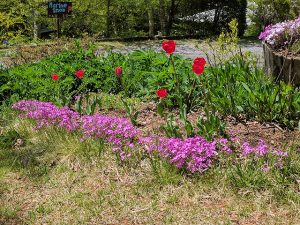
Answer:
[{"left": 0, "top": 37, "right": 300, "bottom": 129}]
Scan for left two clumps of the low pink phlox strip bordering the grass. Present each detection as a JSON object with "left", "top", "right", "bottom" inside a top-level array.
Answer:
[{"left": 13, "top": 100, "right": 139, "bottom": 158}]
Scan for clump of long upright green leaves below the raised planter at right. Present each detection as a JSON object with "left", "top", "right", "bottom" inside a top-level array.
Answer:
[{"left": 206, "top": 57, "right": 300, "bottom": 127}]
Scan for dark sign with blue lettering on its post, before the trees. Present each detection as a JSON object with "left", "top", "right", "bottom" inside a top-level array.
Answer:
[{"left": 48, "top": 2, "right": 72, "bottom": 38}]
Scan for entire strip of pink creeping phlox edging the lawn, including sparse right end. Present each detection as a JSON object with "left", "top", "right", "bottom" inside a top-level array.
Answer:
[{"left": 12, "top": 100, "right": 288, "bottom": 173}]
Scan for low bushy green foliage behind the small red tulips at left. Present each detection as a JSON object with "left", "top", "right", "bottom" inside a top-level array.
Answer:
[{"left": 0, "top": 42, "right": 202, "bottom": 107}]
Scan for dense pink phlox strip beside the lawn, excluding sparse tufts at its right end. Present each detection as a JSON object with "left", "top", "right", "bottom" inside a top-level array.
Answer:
[{"left": 13, "top": 100, "right": 216, "bottom": 173}]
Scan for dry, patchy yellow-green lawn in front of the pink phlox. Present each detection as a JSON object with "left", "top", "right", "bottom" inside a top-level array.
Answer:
[{"left": 0, "top": 108, "right": 300, "bottom": 224}]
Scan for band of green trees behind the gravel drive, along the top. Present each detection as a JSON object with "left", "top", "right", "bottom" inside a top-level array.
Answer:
[{"left": 4, "top": 0, "right": 292, "bottom": 42}]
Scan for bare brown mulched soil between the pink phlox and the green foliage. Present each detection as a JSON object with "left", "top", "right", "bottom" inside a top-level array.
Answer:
[{"left": 98, "top": 103, "right": 300, "bottom": 149}]
